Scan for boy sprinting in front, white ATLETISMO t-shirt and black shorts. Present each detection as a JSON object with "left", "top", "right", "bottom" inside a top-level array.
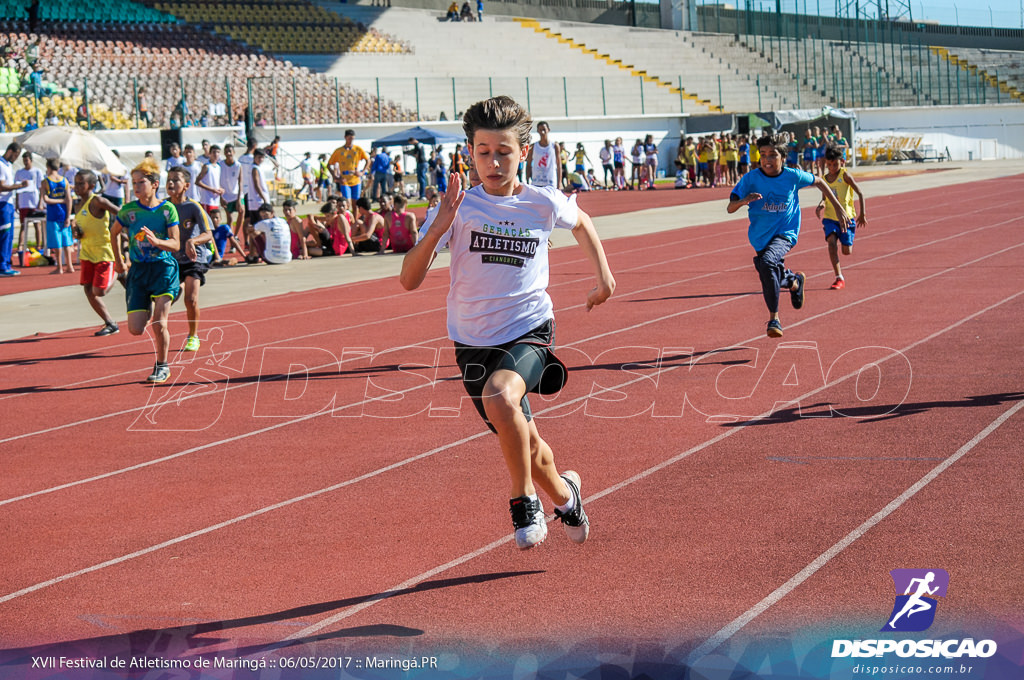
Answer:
[{"left": 400, "top": 96, "right": 615, "bottom": 549}]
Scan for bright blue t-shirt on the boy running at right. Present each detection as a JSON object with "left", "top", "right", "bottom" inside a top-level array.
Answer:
[{"left": 732, "top": 168, "right": 814, "bottom": 253}]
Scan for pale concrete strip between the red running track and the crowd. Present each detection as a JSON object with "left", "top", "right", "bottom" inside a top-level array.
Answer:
[{"left": 0, "top": 161, "right": 1024, "bottom": 341}]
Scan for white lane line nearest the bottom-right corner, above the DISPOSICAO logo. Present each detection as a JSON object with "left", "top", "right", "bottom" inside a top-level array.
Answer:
[{"left": 686, "top": 401, "right": 1024, "bottom": 666}]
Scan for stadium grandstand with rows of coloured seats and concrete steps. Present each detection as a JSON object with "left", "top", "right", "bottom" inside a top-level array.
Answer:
[{"left": 0, "top": 0, "right": 1024, "bottom": 131}]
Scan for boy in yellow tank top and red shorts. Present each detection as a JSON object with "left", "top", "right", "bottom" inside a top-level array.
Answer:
[{"left": 73, "top": 170, "right": 120, "bottom": 336}]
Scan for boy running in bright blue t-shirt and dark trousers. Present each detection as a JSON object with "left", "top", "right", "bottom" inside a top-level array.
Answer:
[{"left": 728, "top": 136, "right": 849, "bottom": 338}]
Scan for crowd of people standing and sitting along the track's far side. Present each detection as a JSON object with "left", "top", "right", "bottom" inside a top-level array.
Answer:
[{"left": 0, "top": 121, "right": 850, "bottom": 275}]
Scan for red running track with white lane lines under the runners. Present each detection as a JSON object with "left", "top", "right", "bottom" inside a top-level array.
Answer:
[{"left": 0, "top": 177, "right": 1024, "bottom": 675}]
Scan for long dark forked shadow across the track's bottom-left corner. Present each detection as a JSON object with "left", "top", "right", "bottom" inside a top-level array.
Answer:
[{"left": 0, "top": 569, "right": 544, "bottom": 669}]
